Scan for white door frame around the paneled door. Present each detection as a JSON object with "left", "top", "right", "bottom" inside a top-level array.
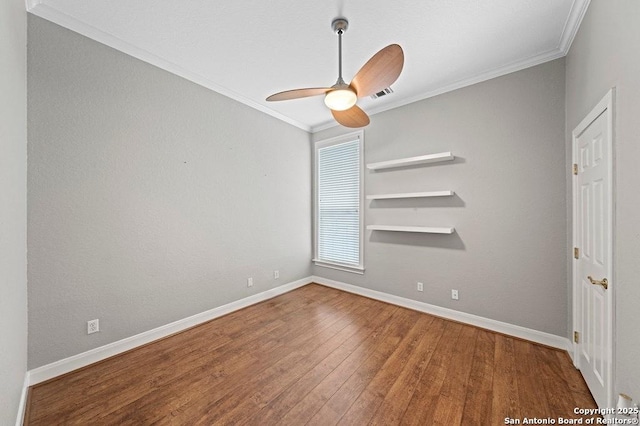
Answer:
[{"left": 571, "top": 87, "right": 616, "bottom": 408}]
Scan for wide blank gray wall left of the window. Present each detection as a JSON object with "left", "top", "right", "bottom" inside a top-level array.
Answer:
[{"left": 28, "top": 16, "right": 311, "bottom": 368}]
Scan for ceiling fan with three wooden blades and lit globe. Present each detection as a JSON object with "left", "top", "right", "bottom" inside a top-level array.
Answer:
[{"left": 266, "top": 18, "right": 404, "bottom": 127}]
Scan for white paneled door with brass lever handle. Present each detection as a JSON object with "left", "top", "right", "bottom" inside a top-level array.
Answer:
[{"left": 573, "top": 92, "right": 615, "bottom": 408}]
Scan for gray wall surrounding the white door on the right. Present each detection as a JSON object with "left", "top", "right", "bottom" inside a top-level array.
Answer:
[{"left": 566, "top": 0, "right": 640, "bottom": 401}]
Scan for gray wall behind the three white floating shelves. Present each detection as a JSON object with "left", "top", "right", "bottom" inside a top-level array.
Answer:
[{"left": 313, "top": 59, "right": 567, "bottom": 336}]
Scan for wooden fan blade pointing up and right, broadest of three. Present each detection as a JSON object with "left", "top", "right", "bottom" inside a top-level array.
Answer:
[{"left": 351, "top": 44, "right": 404, "bottom": 98}]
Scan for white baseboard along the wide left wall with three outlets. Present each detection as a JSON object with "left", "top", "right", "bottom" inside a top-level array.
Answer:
[{"left": 27, "top": 277, "right": 312, "bottom": 386}]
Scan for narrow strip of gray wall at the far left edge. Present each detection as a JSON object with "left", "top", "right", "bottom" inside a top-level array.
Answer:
[{"left": 0, "top": 1, "right": 27, "bottom": 425}]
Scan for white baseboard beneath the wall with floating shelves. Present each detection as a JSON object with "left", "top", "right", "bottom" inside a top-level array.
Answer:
[{"left": 311, "top": 276, "right": 571, "bottom": 350}]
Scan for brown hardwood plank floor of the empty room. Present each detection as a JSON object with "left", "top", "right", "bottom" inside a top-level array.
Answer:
[{"left": 25, "top": 284, "right": 596, "bottom": 426}]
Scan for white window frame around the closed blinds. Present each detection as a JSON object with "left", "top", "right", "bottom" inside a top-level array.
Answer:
[{"left": 312, "top": 130, "right": 365, "bottom": 274}]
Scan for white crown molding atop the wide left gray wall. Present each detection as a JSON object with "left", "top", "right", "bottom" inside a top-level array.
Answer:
[{"left": 26, "top": 0, "right": 311, "bottom": 132}]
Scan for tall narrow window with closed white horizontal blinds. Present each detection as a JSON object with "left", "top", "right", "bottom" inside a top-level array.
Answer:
[{"left": 314, "top": 131, "right": 364, "bottom": 273}]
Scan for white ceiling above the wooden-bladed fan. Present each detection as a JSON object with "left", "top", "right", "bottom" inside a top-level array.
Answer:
[{"left": 27, "top": 0, "right": 589, "bottom": 132}]
